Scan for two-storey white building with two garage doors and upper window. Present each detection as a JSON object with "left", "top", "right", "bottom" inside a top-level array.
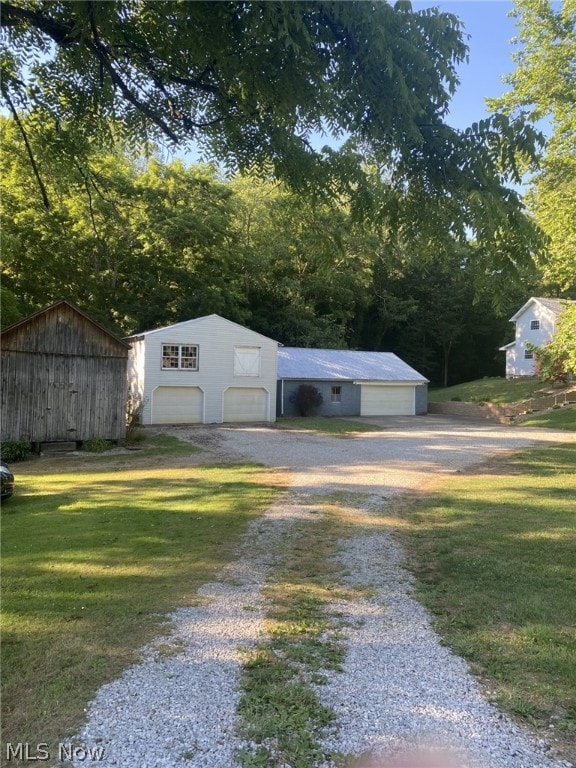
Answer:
[{"left": 126, "top": 315, "right": 278, "bottom": 424}]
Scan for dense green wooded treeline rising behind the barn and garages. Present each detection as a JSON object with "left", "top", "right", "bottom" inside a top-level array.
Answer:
[{"left": 1, "top": 119, "right": 568, "bottom": 384}]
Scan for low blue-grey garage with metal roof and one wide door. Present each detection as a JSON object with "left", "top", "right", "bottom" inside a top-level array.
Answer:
[{"left": 277, "top": 347, "right": 428, "bottom": 416}]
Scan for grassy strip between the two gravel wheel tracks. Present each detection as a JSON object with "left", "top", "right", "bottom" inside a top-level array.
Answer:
[{"left": 238, "top": 496, "right": 366, "bottom": 768}]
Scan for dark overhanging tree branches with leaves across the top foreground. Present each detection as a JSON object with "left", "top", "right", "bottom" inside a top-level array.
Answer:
[{"left": 1, "top": 0, "right": 537, "bottom": 260}]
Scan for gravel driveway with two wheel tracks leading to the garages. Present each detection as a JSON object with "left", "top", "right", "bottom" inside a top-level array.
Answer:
[{"left": 74, "top": 416, "right": 576, "bottom": 768}]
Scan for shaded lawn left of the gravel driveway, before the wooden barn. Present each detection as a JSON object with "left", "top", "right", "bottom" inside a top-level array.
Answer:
[{"left": 2, "top": 437, "right": 277, "bottom": 760}]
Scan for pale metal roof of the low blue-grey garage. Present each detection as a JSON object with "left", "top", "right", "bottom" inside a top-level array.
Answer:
[{"left": 278, "top": 347, "right": 428, "bottom": 384}]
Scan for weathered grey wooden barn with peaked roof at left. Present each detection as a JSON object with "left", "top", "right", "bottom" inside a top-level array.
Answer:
[{"left": 0, "top": 301, "right": 129, "bottom": 443}]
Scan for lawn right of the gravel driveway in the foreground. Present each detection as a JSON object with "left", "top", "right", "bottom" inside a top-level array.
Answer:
[{"left": 400, "top": 445, "right": 576, "bottom": 760}]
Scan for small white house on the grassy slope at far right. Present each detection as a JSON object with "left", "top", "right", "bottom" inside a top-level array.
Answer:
[{"left": 500, "top": 296, "right": 573, "bottom": 379}]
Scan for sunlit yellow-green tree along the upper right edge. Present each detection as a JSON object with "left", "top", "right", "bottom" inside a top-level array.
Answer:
[{"left": 491, "top": 0, "right": 576, "bottom": 295}]
